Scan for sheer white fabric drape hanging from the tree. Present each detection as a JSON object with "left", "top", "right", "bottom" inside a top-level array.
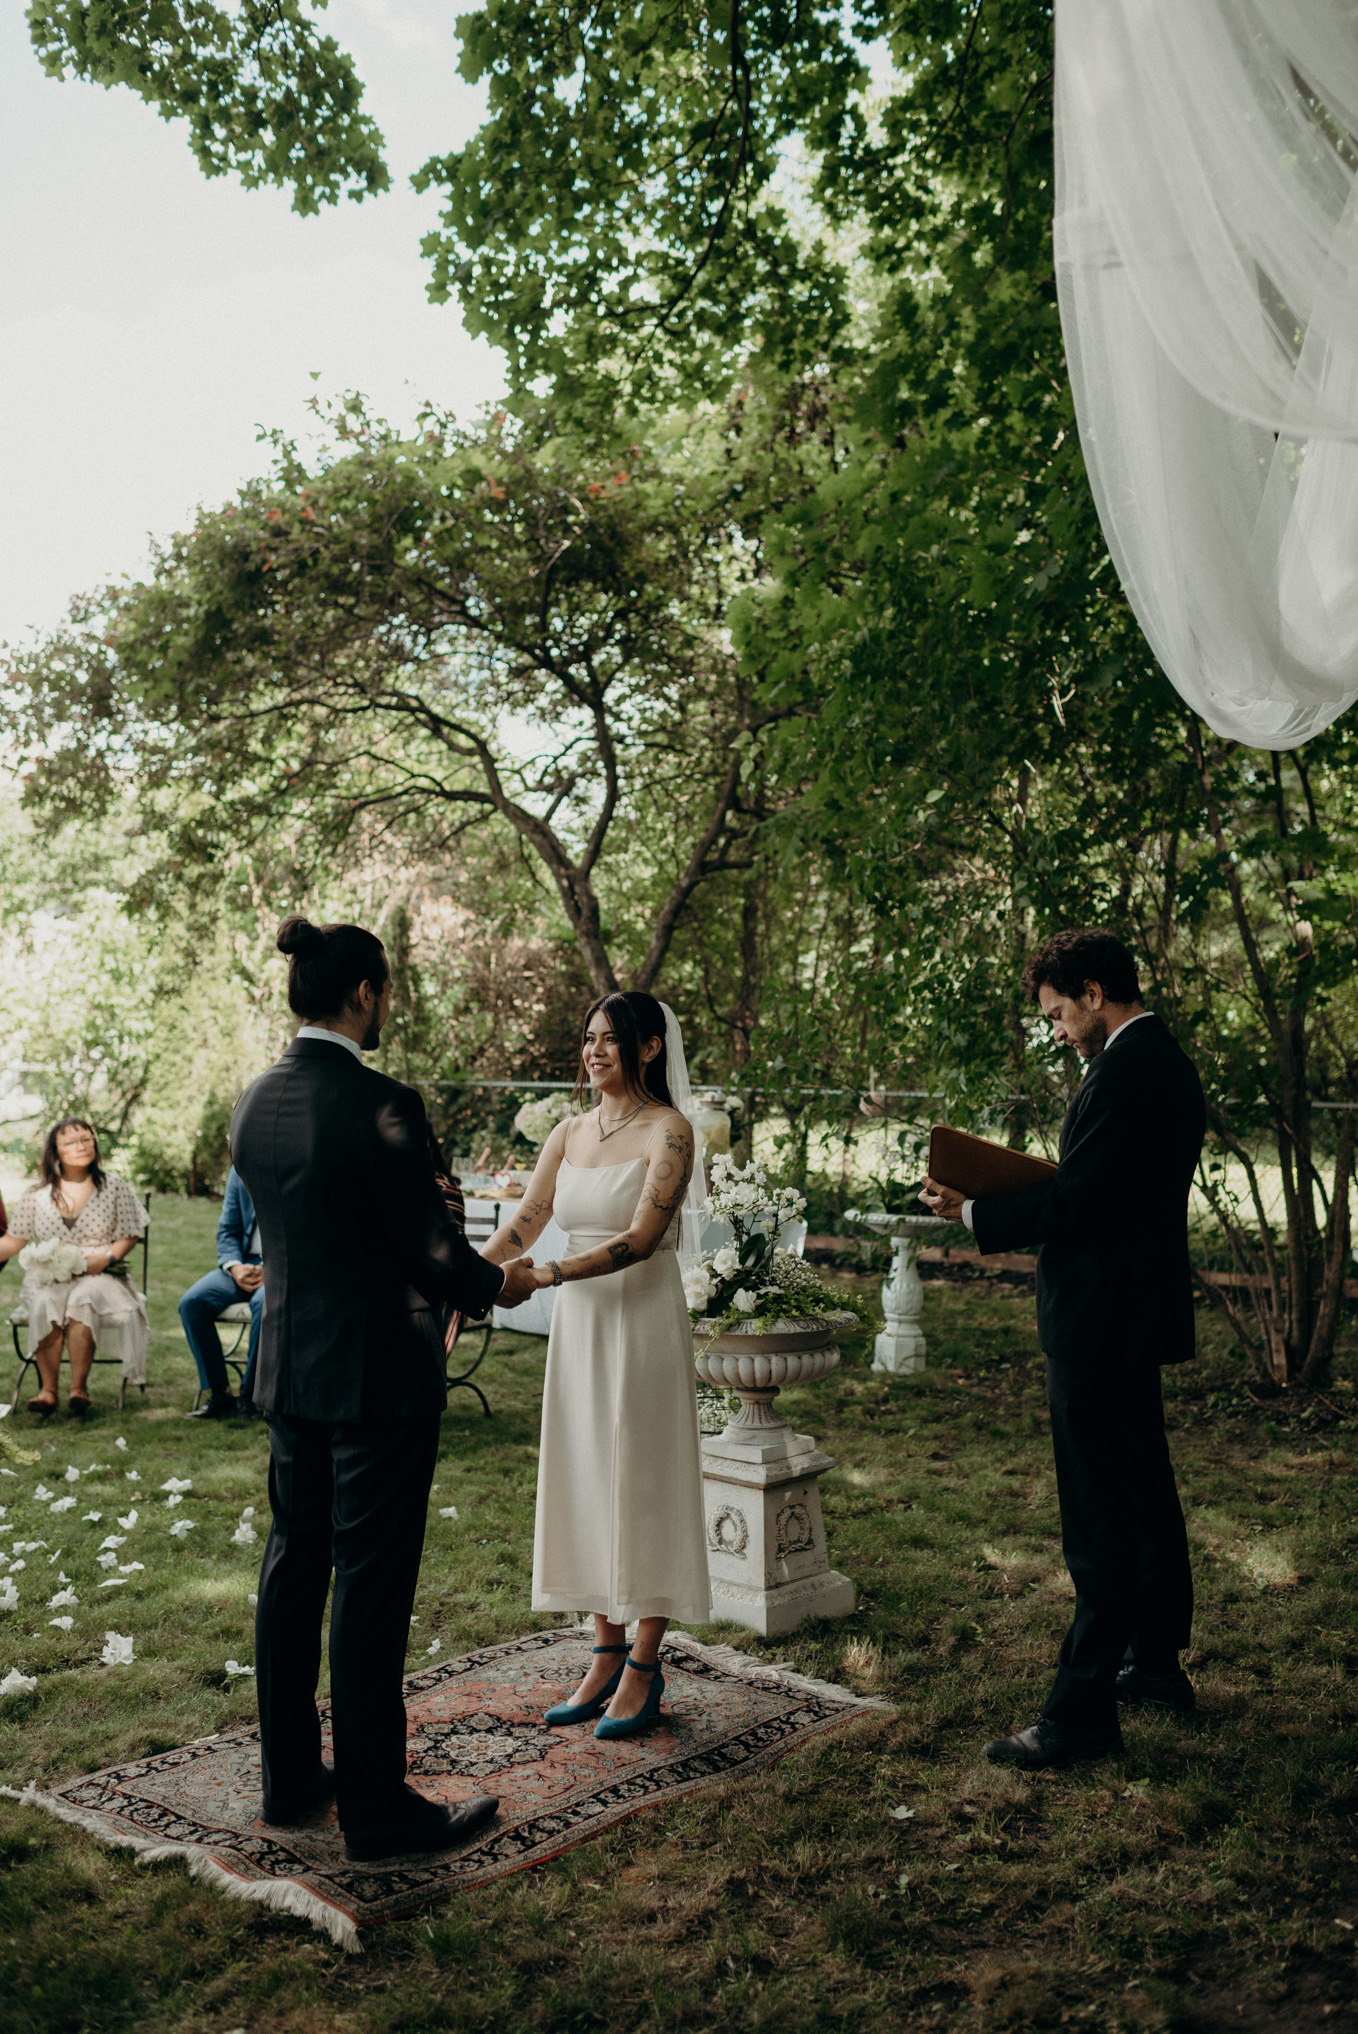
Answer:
[{"left": 1055, "top": 0, "right": 1358, "bottom": 749}]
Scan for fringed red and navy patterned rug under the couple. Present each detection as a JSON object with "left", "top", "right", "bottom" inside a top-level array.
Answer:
[{"left": 0, "top": 1627, "right": 890, "bottom": 1951}]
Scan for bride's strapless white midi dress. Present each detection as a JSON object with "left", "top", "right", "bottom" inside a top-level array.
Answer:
[{"left": 533, "top": 1157, "right": 712, "bottom": 1625}]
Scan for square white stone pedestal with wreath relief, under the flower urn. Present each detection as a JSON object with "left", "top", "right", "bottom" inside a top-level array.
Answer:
[{"left": 703, "top": 1424, "right": 854, "bottom": 1637}]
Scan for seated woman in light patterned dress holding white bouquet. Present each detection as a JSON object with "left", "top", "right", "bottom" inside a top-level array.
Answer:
[{"left": 0, "top": 1117, "right": 148, "bottom": 1418}]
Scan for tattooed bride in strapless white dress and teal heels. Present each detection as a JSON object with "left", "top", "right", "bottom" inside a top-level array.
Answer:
[{"left": 486, "top": 991, "right": 712, "bottom": 1737}]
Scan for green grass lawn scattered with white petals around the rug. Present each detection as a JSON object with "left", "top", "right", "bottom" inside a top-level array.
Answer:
[{"left": 0, "top": 1200, "right": 1358, "bottom": 2034}]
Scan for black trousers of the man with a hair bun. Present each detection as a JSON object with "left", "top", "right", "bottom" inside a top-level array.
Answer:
[{"left": 254, "top": 1410, "right": 439, "bottom": 1829}]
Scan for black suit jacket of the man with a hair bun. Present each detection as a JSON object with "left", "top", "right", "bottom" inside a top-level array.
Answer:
[{"left": 232, "top": 1037, "right": 504, "bottom": 1422}]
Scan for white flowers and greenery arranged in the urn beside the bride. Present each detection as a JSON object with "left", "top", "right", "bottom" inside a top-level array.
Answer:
[{"left": 683, "top": 1153, "right": 874, "bottom": 1334}]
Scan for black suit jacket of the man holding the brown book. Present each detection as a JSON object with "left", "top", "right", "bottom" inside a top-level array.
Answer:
[{"left": 972, "top": 1015, "right": 1206, "bottom": 1363}]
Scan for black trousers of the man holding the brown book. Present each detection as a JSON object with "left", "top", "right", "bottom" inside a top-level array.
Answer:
[{"left": 1043, "top": 1359, "right": 1193, "bottom": 1733}]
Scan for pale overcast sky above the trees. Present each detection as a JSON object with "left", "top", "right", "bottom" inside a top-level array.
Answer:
[{"left": 0, "top": 0, "right": 500, "bottom": 643}]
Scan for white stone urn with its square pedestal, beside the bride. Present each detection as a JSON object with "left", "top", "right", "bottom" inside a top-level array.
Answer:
[{"left": 693, "top": 1314, "right": 856, "bottom": 1637}]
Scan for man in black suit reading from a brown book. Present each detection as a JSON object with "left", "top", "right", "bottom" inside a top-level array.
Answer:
[{"left": 921, "top": 932, "right": 1206, "bottom": 1768}]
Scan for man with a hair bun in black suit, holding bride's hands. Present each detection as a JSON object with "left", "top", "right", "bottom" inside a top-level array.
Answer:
[{"left": 232, "top": 917, "right": 533, "bottom": 1861}]
